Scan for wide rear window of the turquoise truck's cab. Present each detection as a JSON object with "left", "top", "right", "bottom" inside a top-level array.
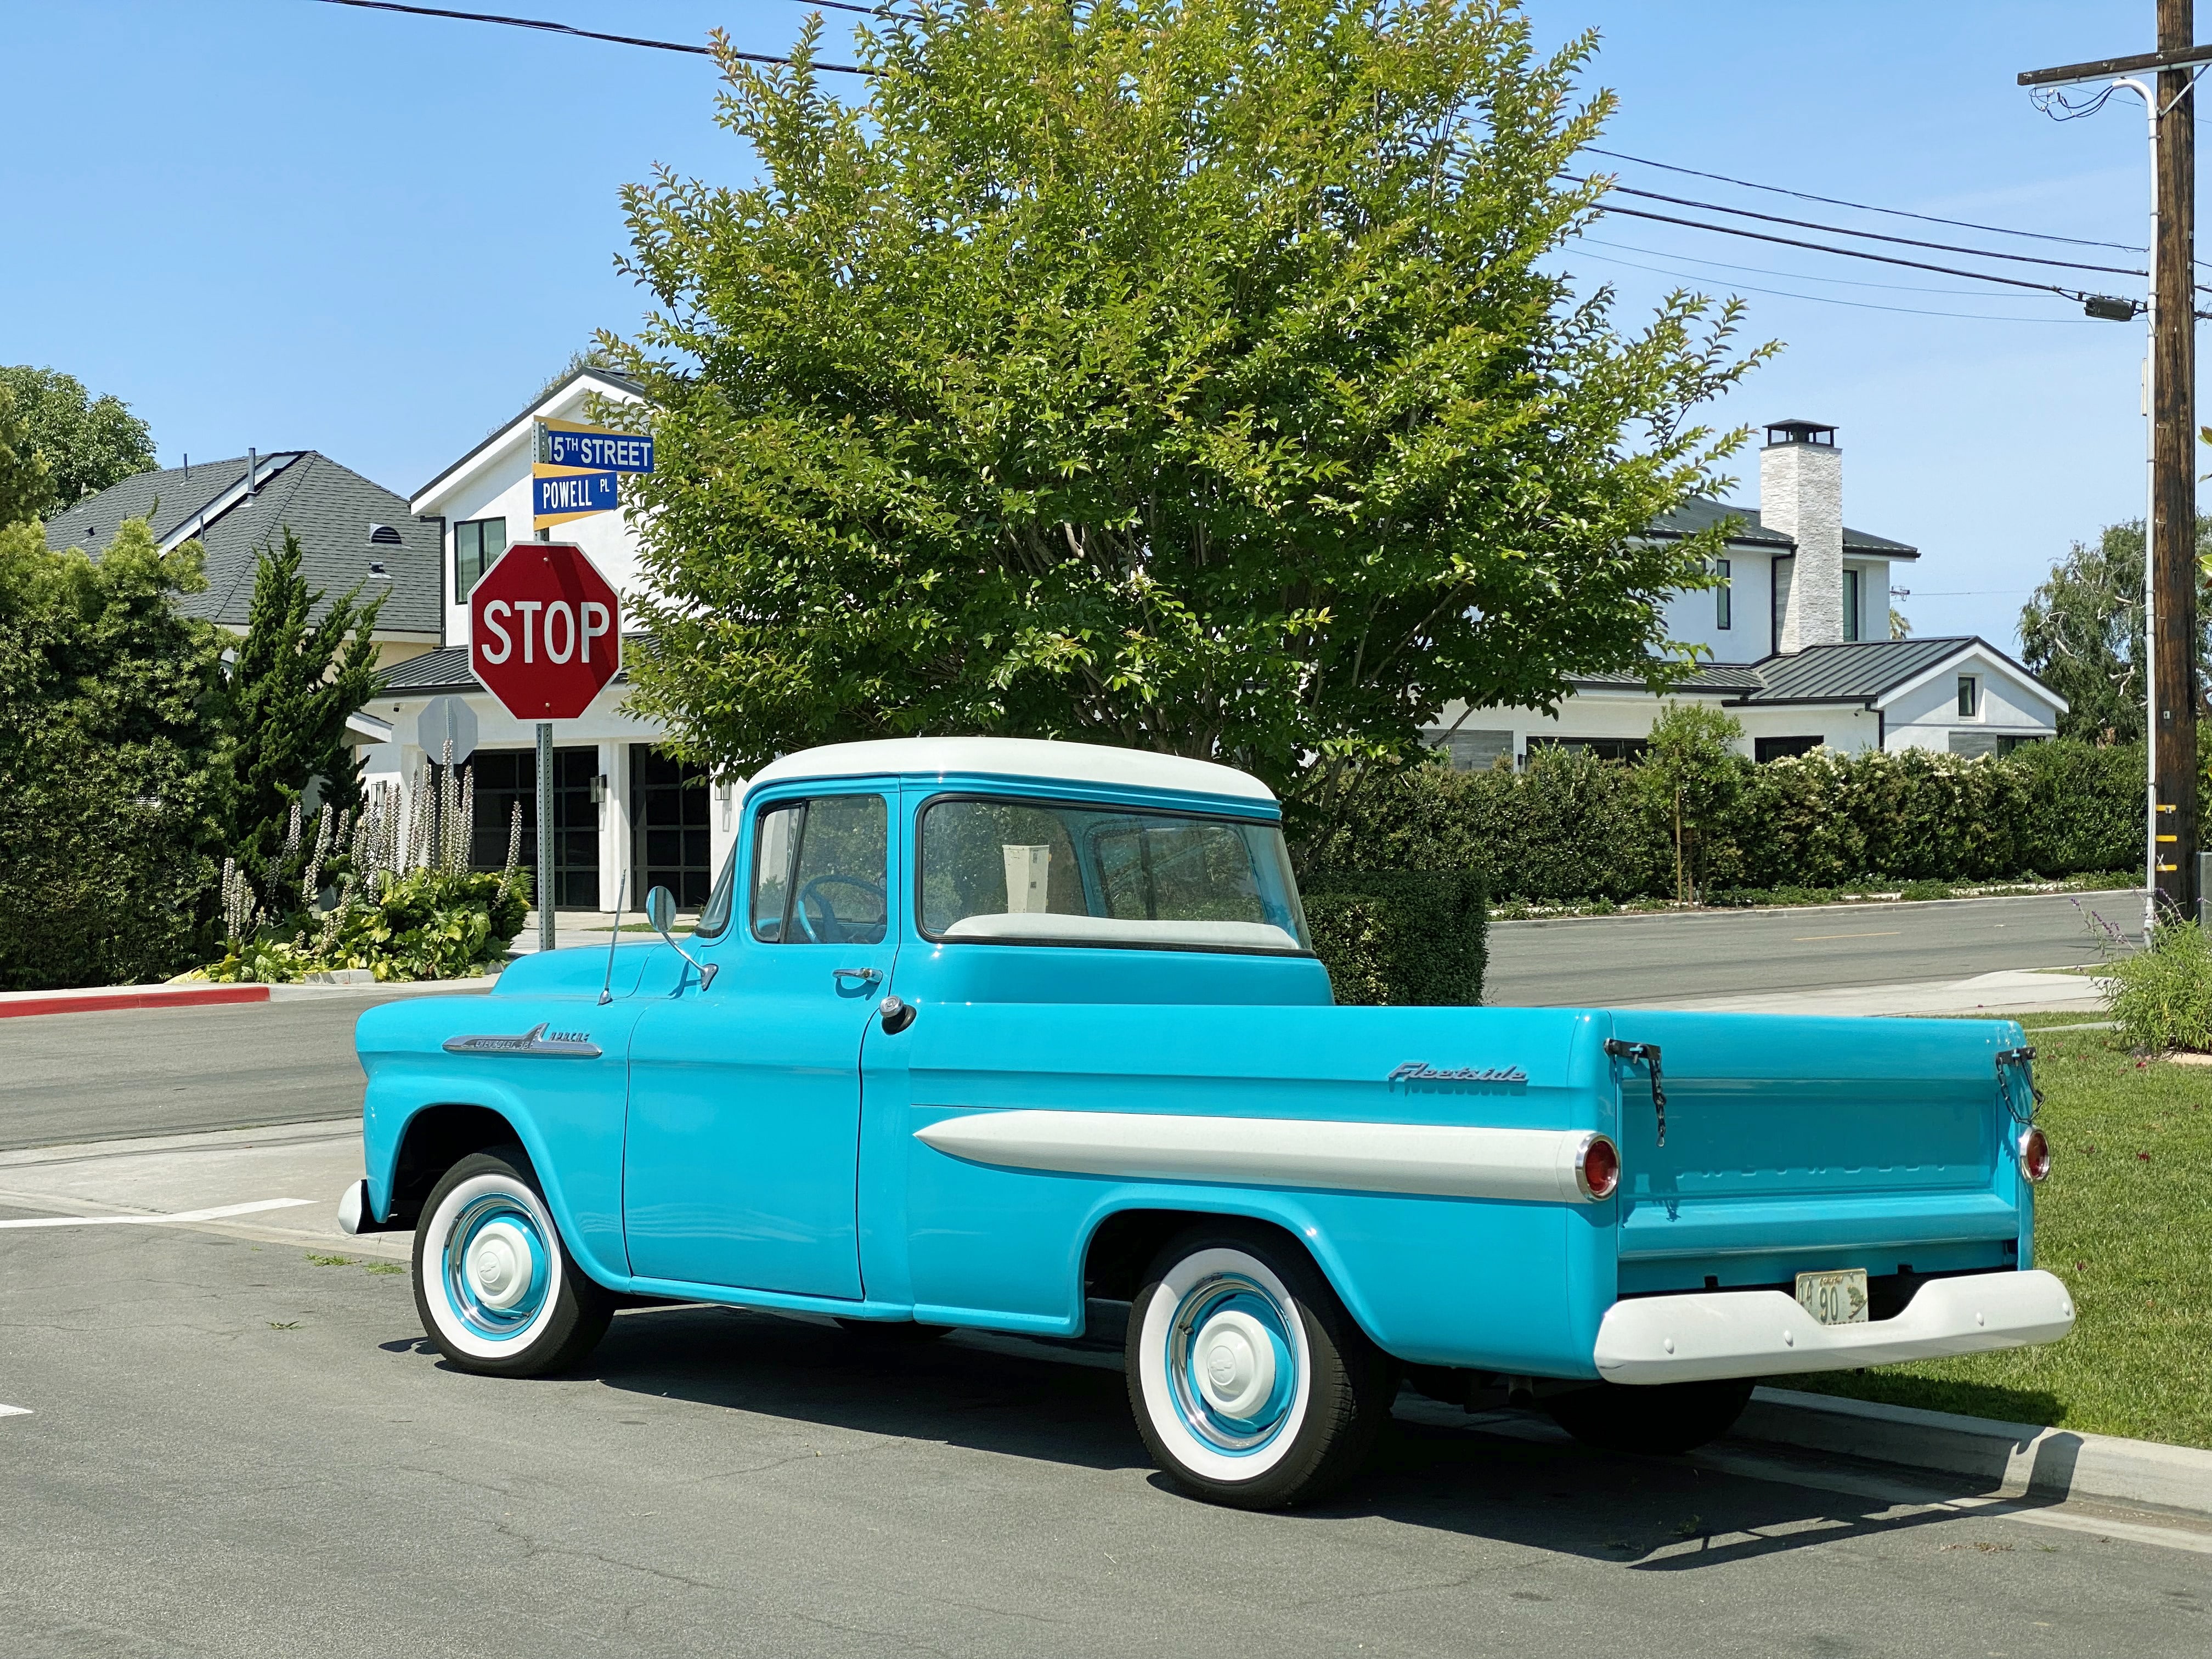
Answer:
[{"left": 920, "top": 799, "right": 1312, "bottom": 951}]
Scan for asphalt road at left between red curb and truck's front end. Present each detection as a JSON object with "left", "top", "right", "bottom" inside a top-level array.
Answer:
[{"left": 0, "top": 993, "right": 484, "bottom": 1150}]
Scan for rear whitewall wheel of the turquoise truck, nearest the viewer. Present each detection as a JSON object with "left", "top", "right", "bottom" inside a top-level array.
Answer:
[{"left": 1124, "top": 1223, "right": 1396, "bottom": 1509}]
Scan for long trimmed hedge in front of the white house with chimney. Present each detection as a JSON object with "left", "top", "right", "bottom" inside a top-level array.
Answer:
[{"left": 1303, "top": 739, "right": 2143, "bottom": 905}]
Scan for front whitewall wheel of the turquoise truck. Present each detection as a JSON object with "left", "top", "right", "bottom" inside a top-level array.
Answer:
[{"left": 414, "top": 1146, "right": 615, "bottom": 1376}]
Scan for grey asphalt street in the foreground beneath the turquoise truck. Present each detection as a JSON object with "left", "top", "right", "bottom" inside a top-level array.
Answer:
[{"left": 0, "top": 1124, "right": 2212, "bottom": 1659}]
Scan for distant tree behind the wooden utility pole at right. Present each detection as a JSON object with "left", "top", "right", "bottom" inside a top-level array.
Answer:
[{"left": 2019, "top": 517, "right": 2212, "bottom": 743}]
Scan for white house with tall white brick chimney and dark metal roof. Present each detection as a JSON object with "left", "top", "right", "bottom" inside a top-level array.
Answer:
[{"left": 1429, "top": 420, "right": 2066, "bottom": 768}]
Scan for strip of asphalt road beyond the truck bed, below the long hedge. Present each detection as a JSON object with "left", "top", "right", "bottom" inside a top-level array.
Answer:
[{"left": 1482, "top": 891, "right": 2141, "bottom": 1007}]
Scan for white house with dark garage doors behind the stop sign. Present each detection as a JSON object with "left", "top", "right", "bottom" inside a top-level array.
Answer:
[{"left": 360, "top": 369, "right": 737, "bottom": 909}]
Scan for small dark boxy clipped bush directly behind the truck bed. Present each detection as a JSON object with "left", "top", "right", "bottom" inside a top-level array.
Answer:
[{"left": 1301, "top": 870, "right": 1489, "bottom": 1007}]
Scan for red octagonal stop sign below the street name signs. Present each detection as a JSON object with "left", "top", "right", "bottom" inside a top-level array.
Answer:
[{"left": 469, "top": 542, "right": 622, "bottom": 721}]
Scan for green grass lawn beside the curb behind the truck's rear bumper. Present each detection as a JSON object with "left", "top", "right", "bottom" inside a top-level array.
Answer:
[{"left": 1772, "top": 1013, "right": 2212, "bottom": 1447}]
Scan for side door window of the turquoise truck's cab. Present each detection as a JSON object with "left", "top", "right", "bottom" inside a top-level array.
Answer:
[{"left": 752, "top": 794, "right": 891, "bottom": 945}]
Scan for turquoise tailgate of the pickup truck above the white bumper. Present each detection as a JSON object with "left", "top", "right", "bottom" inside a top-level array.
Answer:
[{"left": 1610, "top": 1011, "right": 2028, "bottom": 1294}]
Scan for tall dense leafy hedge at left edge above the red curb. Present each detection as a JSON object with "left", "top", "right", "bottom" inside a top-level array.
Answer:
[{"left": 0, "top": 520, "right": 223, "bottom": 991}]
